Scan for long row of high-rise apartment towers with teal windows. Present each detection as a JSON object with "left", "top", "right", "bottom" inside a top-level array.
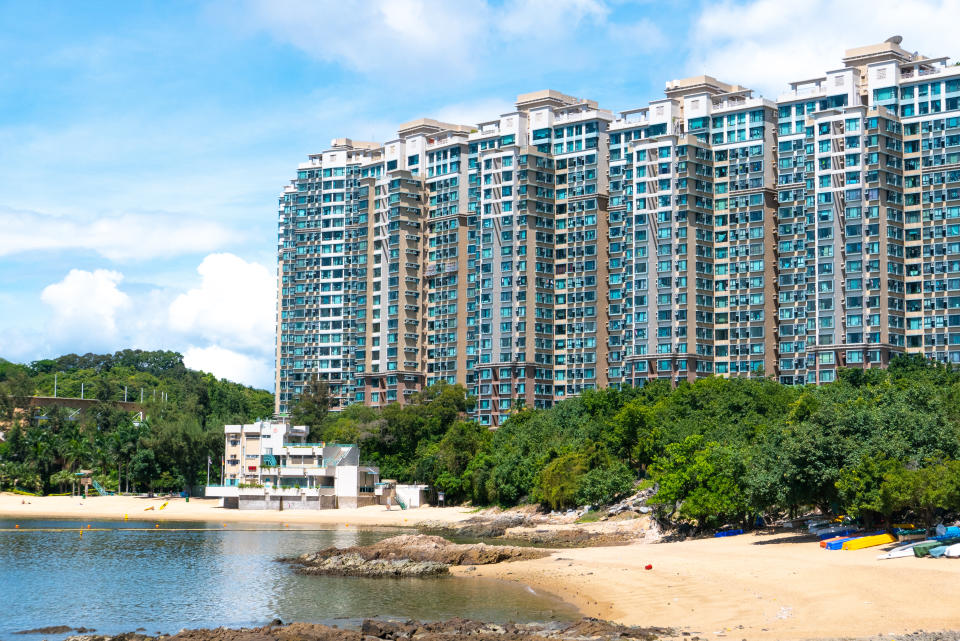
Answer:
[{"left": 277, "top": 38, "right": 960, "bottom": 426}]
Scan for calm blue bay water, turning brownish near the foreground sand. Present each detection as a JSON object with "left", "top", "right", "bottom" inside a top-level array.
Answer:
[{"left": 0, "top": 519, "right": 576, "bottom": 641}]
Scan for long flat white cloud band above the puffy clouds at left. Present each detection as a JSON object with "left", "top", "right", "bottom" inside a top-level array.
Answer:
[{"left": 0, "top": 209, "right": 240, "bottom": 261}]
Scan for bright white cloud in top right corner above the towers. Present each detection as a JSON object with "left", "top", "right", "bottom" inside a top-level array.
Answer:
[{"left": 687, "top": 0, "right": 960, "bottom": 98}]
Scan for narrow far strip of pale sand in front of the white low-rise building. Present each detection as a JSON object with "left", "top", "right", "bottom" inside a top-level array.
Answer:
[{"left": 0, "top": 493, "right": 472, "bottom": 527}]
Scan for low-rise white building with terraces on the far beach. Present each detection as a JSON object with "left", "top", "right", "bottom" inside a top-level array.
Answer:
[{"left": 206, "top": 421, "right": 380, "bottom": 510}]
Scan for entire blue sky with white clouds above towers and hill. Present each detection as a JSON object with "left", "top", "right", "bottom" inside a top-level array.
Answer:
[{"left": 0, "top": 0, "right": 960, "bottom": 389}]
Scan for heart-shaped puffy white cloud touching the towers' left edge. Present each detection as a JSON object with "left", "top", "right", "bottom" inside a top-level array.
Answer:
[{"left": 168, "top": 254, "right": 277, "bottom": 354}]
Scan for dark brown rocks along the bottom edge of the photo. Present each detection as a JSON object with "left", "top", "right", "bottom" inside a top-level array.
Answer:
[{"left": 65, "top": 619, "right": 673, "bottom": 641}]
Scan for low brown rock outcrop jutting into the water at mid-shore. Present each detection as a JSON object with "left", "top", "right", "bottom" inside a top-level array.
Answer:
[{"left": 281, "top": 534, "right": 549, "bottom": 578}]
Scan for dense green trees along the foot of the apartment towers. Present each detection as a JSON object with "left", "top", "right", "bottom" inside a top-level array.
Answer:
[{"left": 294, "top": 357, "right": 960, "bottom": 527}]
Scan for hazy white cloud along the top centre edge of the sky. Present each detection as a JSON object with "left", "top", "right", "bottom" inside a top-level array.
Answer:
[{"left": 234, "top": 0, "right": 644, "bottom": 79}]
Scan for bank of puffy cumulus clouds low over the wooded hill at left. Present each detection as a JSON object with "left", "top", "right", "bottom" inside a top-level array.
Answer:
[{"left": 30, "top": 254, "right": 276, "bottom": 389}]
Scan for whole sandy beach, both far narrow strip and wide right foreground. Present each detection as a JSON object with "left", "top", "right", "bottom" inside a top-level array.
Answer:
[{"left": 0, "top": 494, "right": 960, "bottom": 640}]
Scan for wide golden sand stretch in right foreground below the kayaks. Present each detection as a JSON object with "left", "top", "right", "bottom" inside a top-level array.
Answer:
[{"left": 453, "top": 534, "right": 960, "bottom": 640}]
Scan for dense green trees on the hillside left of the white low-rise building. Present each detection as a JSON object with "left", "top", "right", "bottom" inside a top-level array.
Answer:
[{"left": 0, "top": 350, "right": 273, "bottom": 492}]
